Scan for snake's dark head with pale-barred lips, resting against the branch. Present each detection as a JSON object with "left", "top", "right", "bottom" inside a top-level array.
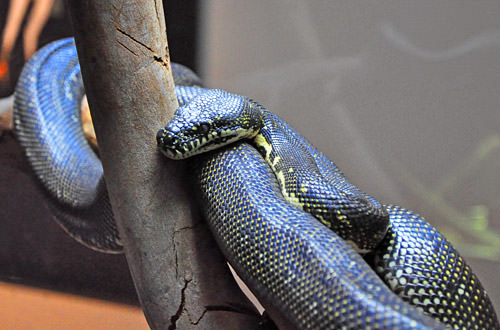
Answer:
[{"left": 156, "top": 89, "right": 264, "bottom": 159}]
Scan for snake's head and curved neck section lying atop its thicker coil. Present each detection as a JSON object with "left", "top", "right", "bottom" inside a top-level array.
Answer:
[{"left": 157, "top": 87, "right": 389, "bottom": 252}]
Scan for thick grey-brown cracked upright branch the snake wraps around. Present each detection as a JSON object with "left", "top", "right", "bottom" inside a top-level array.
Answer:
[{"left": 67, "top": 0, "right": 259, "bottom": 329}]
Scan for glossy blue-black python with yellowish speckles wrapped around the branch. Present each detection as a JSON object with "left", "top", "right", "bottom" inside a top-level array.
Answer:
[{"left": 14, "top": 39, "right": 500, "bottom": 329}]
